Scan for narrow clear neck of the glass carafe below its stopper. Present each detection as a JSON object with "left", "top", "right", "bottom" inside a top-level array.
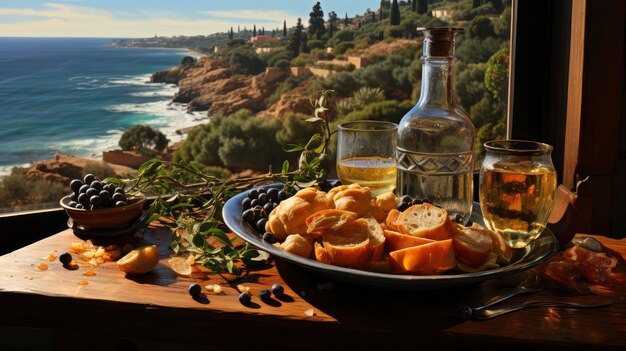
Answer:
[{"left": 417, "top": 57, "right": 456, "bottom": 108}]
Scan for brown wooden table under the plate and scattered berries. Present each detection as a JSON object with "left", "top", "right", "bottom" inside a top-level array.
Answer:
[{"left": 0, "top": 229, "right": 626, "bottom": 351}]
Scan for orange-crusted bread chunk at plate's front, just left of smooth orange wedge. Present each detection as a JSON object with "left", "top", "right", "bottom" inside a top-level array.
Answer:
[{"left": 322, "top": 218, "right": 372, "bottom": 268}]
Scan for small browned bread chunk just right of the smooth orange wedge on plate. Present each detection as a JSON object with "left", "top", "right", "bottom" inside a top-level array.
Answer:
[{"left": 452, "top": 225, "right": 493, "bottom": 268}]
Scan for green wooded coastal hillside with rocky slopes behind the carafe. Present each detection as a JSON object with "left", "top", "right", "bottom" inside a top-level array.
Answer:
[{"left": 158, "top": 0, "right": 511, "bottom": 176}]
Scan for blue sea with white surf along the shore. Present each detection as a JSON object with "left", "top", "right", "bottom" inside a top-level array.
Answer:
[{"left": 0, "top": 37, "right": 206, "bottom": 174}]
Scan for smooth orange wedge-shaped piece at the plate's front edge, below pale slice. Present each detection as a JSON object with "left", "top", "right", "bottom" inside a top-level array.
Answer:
[{"left": 389, "top": 239, "right": 456, "bottom": 274}]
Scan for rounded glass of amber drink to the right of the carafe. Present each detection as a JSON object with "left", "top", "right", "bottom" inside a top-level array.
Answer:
[{"left": 480, "top": 140, "right": 556, "bottom": 248}]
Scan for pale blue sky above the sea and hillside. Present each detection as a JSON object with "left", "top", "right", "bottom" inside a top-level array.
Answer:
[{"left": 0, "top": 0, "right": 380, "bottom": 38}]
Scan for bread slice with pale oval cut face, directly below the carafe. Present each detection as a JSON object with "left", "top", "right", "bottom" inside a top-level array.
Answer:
[{"left": 396, "top": 203, "right": 452, "bottom": 240}]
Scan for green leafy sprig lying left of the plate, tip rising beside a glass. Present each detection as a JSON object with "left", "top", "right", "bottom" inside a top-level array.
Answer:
[{"left": 105, "top": 90, "right": 334, "bottom": 275}]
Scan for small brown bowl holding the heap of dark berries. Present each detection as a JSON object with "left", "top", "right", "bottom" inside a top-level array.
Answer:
[{"left": 59, "top": 195, "right": 146, "bottom": 230}]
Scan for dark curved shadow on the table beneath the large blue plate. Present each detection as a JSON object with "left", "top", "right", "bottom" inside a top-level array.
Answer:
[{"left": 275, "top": 260, "right": 532, "bottom": 331}]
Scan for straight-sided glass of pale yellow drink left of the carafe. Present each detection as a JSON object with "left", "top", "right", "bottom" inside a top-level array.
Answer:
[{"left": 337, "top": 120, "right": 398, "bottom": 196}]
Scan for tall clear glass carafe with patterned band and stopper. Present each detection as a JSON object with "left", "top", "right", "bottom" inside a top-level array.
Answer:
[{"left": 397, "top": 28, "right": 476, "bottom": 223}]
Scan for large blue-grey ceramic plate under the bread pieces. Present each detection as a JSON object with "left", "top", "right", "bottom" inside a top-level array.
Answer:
[{"left": 222, "top": 184, "right": 558, "bottom": 290}]
